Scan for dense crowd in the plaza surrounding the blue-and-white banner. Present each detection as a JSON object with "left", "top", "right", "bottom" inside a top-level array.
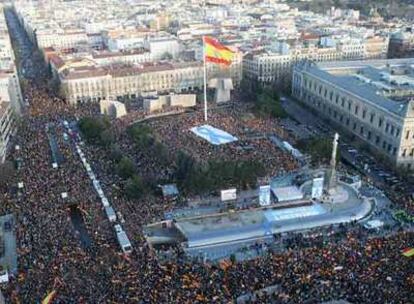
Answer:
[{"left": 142, "top": 104, "right": 298, "bottom": 176}]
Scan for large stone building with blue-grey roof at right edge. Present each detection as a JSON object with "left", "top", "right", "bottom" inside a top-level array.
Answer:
[{"left": 292, "top": 58, "right": 414, "bottom": 170}]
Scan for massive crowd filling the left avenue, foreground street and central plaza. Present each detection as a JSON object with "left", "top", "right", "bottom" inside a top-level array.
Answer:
[{"left": 0, "top": 12, "right": 414, "bottom": 303}]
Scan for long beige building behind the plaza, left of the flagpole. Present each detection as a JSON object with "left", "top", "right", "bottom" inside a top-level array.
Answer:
[{"left": 58, "top": 55, "right": 241, "bottom": 104}]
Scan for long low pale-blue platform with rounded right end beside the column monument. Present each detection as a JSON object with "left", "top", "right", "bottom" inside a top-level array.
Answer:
[{"left": 174, "top": 184, "right": 372, "bottom": 249}]
